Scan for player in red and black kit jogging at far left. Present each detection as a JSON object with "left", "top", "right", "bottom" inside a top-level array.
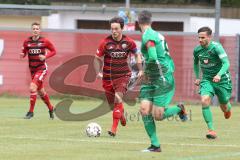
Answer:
[{"left": 20, "top": 22, "right": 56, "bottom": 119}]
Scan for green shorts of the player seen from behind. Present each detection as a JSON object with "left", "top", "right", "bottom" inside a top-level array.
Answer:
[{"left": 140, "top": 74, "right": 175, "bottom": 107}]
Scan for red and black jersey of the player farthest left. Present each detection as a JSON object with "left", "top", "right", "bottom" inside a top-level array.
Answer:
[{"left": 22, "top": 37, "right": 56, "bottom": 74}]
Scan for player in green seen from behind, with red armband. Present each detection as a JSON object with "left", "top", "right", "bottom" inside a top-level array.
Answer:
[{"left": 138, "top": 11, "right": 187, "bottom": 152}]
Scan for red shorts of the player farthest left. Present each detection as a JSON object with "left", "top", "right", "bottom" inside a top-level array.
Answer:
[{"left": 31, "top": 70, "right": 47, "bottom": 90}]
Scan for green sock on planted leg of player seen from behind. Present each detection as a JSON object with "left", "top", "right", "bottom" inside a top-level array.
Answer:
[{"left": 142, "top": 115, "right": 160, "bottom": 147}]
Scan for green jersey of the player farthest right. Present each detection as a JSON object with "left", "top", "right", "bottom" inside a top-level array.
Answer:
[{"left": 193, "top": 41, "right": 229, "bottom": 80}]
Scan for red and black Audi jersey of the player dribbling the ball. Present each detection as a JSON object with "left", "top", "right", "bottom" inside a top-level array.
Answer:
[{"left": 96, "top": 35, "right": 137, "bottom": 80}]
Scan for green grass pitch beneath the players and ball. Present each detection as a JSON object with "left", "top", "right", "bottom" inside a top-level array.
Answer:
[{"left": 0, "top": 97, "right": 240, "bottom": 160}]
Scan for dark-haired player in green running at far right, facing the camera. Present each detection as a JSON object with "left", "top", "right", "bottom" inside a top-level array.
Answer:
[{"left": 193, "top": 27, "right": 232, "bottom": 139}]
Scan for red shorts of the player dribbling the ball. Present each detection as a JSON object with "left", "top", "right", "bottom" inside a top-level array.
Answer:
[{"left": 102, "top": 76, "right": 130, "bottom": 104}]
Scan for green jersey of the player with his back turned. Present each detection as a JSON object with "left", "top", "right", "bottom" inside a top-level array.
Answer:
[{"left": 141, "top": 27, "right": 174, "bottom": 77}]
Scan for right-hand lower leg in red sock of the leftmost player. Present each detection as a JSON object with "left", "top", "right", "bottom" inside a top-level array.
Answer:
[{"left": 38, "top": 87, "right": 54, "bottom": 119}]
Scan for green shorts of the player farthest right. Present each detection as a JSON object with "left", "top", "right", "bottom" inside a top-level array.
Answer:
[{"left": 199, "top": 79, "right": 232, "bottom": 104}]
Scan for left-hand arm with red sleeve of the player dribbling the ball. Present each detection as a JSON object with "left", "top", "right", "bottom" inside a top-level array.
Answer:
[{"left": 93, "top": 41, "right": 104, "bottom": 78}]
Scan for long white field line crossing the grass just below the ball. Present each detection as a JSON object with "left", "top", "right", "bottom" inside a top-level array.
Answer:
[{"left": 0, "top": 136, "right": 240, "bottom": 148}]
